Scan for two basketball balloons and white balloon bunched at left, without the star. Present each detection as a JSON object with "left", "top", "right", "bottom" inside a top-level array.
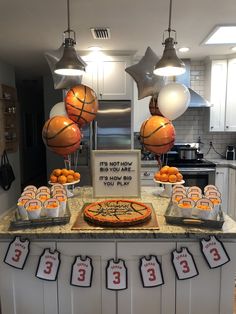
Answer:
[{"left": 42, "top": 84, "right": 98, "bottom": 156}]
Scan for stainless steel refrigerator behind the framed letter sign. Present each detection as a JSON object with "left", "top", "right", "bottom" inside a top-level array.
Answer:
[{"left": 77, "top": 100, "right": 131, "bottom": 186}]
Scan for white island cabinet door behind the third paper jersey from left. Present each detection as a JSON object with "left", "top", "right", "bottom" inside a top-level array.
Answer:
[{"left": 57, "top": 241, "right": 116, "bottom": 314}]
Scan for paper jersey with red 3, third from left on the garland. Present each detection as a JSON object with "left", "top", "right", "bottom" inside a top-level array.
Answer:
[{"left": 70, "top": 255, "right": 93, "bottom": 288}]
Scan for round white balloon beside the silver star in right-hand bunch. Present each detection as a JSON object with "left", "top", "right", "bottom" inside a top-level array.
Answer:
[{"left": 158, "top": 83, "right": 190, "bottom": 120}]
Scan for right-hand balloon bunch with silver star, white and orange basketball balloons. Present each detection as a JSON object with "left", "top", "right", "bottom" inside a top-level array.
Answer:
[{"left": 125, "top": 47, "right": 190, "bottom": 155}]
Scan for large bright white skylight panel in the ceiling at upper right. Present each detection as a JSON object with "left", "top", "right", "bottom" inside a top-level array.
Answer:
[{"left": 203, "top": 25, "right": 236, "bottom": 45}]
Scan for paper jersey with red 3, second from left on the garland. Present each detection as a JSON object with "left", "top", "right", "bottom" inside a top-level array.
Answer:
[{"left": 36, "top": 248, "right": 61, "bottom": 281}]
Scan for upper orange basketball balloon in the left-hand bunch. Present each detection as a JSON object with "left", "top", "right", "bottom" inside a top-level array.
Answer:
[{"left": 65, "top": 84, "right": 98, "bottom": 127}]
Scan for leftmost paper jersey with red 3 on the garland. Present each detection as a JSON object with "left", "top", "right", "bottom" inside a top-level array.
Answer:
[{"left": 4, "top": 237, "right": 30, "bottom": 269}]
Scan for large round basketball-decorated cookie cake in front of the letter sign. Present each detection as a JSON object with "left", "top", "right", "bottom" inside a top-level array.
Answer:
[{"left": 84, "top": 200, "right": 152, "bottom": 227}]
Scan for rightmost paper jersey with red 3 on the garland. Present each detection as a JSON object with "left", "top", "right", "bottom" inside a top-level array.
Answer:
[{"left": 200, "top": 236, "right": 230, "bottom": 268}]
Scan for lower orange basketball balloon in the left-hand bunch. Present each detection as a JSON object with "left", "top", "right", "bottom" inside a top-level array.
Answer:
[{"left": 42, "top": 116, "right": 81, "bottom": 156}]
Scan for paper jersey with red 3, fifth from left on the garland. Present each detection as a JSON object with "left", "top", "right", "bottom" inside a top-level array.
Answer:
[{"left": 139, "top": 255, "right": 164, "bottom": 288}]
